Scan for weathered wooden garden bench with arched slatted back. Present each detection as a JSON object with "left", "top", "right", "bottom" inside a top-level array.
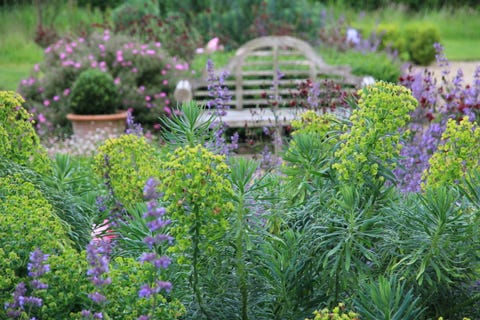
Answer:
[{"left": 175, "top": 36, "right": 370, "bottom": 128}]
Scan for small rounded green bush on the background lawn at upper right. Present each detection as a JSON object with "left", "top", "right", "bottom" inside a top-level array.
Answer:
[{"left": 405, "top": 24, "right": 440, "bottom": 66}]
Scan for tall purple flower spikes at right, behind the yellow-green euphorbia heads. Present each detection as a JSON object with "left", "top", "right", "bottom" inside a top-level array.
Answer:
[{"left": 395, "top": 44, "right": 480, "bottom": 192}]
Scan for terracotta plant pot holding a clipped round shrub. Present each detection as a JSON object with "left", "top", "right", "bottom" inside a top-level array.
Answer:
[{"left": 67, "top": 111, "right": 128, "bottom": 138}]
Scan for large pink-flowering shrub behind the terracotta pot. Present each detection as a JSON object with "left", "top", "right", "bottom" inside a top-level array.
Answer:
[{"left": 18, "top": 30, "right": 189, "bottom": 134}]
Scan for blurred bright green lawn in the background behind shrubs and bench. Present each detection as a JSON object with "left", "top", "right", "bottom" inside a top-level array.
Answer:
[{"left": 0, "top": 4, "right": 480, "bottom": 90}]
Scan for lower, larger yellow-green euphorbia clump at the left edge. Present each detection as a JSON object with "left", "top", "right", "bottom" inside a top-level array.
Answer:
[{"left": 0, "top": 174, "right": 70, "bottom": 318}]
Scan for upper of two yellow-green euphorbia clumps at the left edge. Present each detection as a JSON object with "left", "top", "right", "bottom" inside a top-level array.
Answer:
[{"left": 0, "top": 91, "right": 49, "bottom": 173}]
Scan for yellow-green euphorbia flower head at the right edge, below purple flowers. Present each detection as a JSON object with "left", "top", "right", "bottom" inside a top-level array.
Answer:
[{"left": 422, "top": 117, "right": 480, "bottom": 188}]
